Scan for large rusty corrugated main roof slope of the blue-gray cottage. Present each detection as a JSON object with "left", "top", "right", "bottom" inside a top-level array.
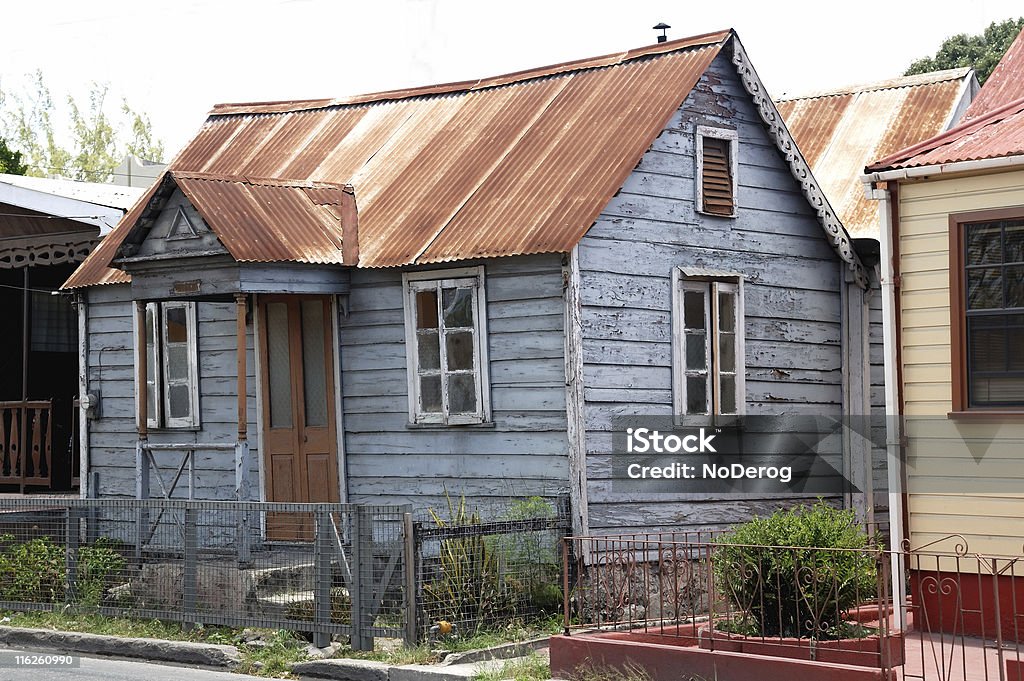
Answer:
[{"left": 66, "top": 31, "right": 733, "bottom": 288}]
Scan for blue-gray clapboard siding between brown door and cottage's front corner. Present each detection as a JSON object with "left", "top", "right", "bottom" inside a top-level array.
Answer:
[{"left": 338, "top": 255, "right": 568, "bottom": 511}]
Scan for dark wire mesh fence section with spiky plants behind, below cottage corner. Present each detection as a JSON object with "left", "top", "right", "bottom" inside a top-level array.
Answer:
[{"left": 415, "top": 497, "right": 570, "bottom": 638}]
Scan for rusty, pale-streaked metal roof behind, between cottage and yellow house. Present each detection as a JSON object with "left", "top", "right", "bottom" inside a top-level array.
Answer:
[{"left": 777, "top": 69, "right": 973, "bottom": 239}]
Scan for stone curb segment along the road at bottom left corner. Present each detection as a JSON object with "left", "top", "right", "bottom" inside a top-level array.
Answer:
[{"left": 0, "top": 627, "right": 242, "bottom": 670}]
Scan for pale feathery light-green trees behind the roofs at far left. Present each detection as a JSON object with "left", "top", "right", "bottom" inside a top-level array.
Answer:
[{"left": 0, "top": 71, "right": 164, "bottom": 182}]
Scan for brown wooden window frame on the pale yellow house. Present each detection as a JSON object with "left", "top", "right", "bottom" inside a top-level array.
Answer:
[{"left": 946, "top": 206, "right": 1024, "bottom": 420}]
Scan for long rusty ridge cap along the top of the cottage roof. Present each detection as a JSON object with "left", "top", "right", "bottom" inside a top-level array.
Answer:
[{"left": 209, "top": 29, "right": 735, "bottom": 117}]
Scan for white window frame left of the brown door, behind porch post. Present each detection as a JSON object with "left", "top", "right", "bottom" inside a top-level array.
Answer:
[{"left": 136, "top": 301, "right": 200, "bottom": 429}]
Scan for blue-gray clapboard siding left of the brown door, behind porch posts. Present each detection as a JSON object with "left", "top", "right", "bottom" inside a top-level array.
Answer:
[{"left": 86, "top": 285, "right": 260, "bottom": 500}]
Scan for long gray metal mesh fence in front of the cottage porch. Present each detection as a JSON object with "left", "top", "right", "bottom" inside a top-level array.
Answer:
[{"left": 0, "top": 498, "right": 415, "bottom": 648}]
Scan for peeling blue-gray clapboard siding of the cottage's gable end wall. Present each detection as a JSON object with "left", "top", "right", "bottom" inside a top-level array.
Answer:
[{"left": 580, "top": 54, "right": 843, "bottom": 534}]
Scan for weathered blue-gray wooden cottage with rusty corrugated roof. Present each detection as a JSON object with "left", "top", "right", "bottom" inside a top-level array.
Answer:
[{"left": 65, "top": 31, "right": 872, "bottom": 531}]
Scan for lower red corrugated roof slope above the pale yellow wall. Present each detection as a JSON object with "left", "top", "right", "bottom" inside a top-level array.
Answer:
[{"left": 866, "top": 97, "right": 1024, "bottom": 172}]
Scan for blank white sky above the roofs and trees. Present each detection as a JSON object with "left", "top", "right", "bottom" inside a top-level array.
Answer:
[{"left": 0, "top": 0, "right": 1024, "bottom": 156}]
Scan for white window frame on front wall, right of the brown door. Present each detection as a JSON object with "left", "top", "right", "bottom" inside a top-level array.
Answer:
[{"left": 401, "top": 265, "right": 490, "bottom": 425}]
